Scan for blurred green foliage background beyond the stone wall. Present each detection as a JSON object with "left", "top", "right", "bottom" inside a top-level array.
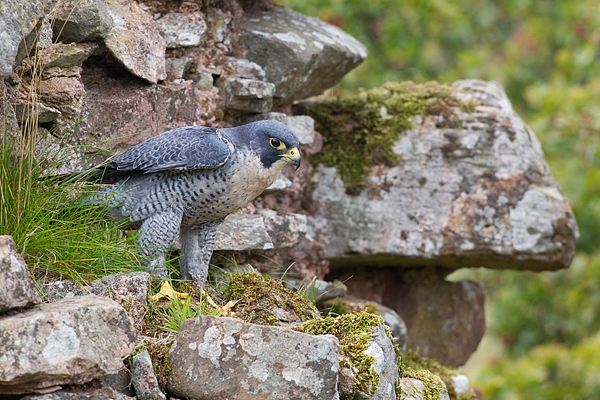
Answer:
[{"left": 281, "top": 0, "right": 600, "bottom": 399}]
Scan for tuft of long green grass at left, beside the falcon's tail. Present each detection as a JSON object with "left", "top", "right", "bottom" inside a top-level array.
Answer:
[{"left": 0, "top": 23, "right": 140, "bottom": 282}]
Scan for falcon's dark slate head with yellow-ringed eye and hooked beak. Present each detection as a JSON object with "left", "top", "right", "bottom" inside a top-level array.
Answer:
[{"left": 235, "top": 120, "right": 300, "bottom": 169}]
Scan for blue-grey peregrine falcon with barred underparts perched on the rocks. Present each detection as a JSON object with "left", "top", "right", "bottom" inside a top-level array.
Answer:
[{"left": 87, "top": 120, "right": 300, "bottom": 287}]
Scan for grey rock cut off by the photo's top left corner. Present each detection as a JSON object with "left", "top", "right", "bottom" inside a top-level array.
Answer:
[{"left": 0, "top": 0, "right": 44, "bottom": 77}]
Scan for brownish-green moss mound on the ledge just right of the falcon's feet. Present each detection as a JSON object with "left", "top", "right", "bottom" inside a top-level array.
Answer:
[{"left": 226, "top": 272, "right": 319, "bottom": 325}]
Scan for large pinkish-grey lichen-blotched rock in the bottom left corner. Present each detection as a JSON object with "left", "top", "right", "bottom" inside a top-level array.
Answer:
[{"left": 0, "top": 295, "right": 137, "bottom": 394}]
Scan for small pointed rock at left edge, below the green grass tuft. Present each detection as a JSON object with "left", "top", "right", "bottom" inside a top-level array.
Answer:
[{"left": 0, "top": 236, "right": 42, "bottom": 313}]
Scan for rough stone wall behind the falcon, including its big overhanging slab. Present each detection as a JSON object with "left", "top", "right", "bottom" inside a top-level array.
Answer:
[{"left": 0, "top": 0, "right": 577, "bottom": 380}]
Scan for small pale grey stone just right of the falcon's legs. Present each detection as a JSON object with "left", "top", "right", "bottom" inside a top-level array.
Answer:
[{"left": 215, "top": 214, "right": 273, "bottom": 251}]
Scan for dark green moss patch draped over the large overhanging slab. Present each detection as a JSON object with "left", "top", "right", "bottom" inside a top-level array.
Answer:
[{"left": 304, "top": 82, "right": 476, "bottom": 193}]
